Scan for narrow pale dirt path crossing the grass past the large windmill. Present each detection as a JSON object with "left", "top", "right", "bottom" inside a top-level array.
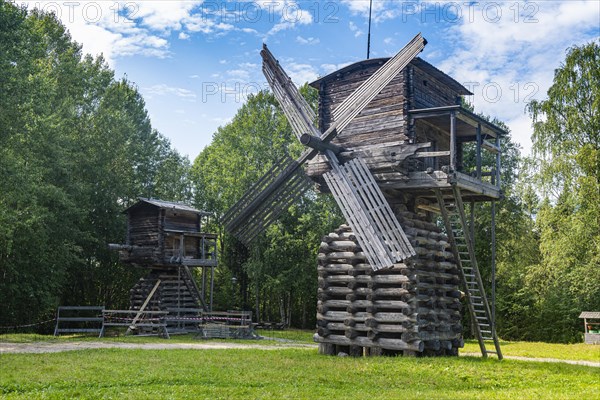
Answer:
[{"left": 0, "top": 341, "right": 600, "bottom": 368}]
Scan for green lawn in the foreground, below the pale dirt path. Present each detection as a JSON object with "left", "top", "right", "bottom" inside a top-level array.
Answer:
[{"left": 0, "top": 349, "right": 600, "bottom": 399}]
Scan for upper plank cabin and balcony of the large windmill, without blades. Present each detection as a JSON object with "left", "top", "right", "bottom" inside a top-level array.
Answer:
[{"left": 306, "top": 58, "right": 507, "bottom": 199}]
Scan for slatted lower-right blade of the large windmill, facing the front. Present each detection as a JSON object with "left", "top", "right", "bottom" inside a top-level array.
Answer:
[{"left": 323, "top": 158, "right": 416, "bottom": 271}]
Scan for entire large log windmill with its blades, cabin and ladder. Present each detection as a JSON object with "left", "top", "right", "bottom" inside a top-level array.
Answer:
[{"left": 223, "top": 34, "right": 505, "bottom": 357}]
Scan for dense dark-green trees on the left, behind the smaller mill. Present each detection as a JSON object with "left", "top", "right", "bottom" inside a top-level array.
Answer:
[{"left": 0, "top": 0, "right": 191, "bottom": 326}]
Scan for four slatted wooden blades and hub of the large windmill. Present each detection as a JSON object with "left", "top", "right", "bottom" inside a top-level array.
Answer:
[{"left": 222, "top": 34, "right": 427, "bottom": 270}]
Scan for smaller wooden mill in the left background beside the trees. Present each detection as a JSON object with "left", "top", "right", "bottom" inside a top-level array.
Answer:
[{"left": 110, "top": 198, "right": 217, "bottom": 332}]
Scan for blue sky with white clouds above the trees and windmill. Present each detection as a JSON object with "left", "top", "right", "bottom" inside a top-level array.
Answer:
[{"left": 19, "top": 0, "right": 600, "bottom": 160}]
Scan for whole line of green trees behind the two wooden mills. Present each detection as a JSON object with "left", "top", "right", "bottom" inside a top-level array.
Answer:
[{"left": 0, "top": 0, "right": 600, "bottom": 342}]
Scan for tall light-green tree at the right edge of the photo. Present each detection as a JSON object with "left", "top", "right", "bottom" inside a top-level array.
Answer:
[{"left": 528, "top": 42, "right": 600, "bottom": 342}]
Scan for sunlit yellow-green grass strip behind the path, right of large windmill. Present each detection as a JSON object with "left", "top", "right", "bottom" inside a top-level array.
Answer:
[{"left": 461, "top": 340, "right": 600, "bottom": 362}]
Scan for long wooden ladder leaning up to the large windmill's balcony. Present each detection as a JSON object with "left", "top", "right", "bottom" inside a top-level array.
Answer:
[{"left": 435, "top": 185, "right": 502, "bottom": 360}]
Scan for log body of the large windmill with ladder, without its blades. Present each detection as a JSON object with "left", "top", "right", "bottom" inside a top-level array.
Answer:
[{"left": 306, "top": 54, "right": 507, "bottom": 358}]
